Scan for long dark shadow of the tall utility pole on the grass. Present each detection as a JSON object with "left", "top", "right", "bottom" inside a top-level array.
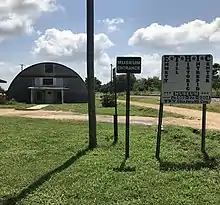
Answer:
[{"left": 0, "top": 148, "right": 91, "bottom": 205}]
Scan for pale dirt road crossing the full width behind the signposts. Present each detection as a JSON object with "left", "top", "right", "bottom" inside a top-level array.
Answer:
[{"left": 0, "top": 108, "right": 220, "bottom": 130}]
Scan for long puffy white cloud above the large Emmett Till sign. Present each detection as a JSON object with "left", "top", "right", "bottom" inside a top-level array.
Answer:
[{"left": 128, "top": 18, "right": 220, "bottom": 52}]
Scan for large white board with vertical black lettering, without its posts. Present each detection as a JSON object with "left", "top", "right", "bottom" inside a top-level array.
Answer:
[{"left": 161, "top": 55, "right": 213, "bottom": 104}]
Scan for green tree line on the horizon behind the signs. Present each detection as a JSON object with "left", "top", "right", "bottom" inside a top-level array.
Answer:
[{"left": 85, "top": 63, "right": 220, "bottom": 95}]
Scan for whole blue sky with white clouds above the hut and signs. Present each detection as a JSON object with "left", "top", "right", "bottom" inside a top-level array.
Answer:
[{"left": 0, "top": 0, "right": 220, "bottom": 89}]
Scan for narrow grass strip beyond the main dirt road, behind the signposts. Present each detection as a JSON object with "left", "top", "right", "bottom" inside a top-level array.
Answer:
[{"left": 44, "top": 100, "right": 185, "bottom": 118}]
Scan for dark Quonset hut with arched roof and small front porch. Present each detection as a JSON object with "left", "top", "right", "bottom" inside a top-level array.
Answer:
[{"left": 7, "top": 62, "right": 88, "bottom": 104}]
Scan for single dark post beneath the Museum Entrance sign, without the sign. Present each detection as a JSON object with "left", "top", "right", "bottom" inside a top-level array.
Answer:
[{"left": 125, "top": 72, "right": 130, "bottom": 159}]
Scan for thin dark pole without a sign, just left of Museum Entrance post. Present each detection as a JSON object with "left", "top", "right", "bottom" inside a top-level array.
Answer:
[{"left": 113, "top": 68, "right": 118, "bottom": 144}]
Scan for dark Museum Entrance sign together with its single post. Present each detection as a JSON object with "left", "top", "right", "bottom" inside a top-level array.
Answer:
[{"left": 116, "top": 57, "right": 141, "bottom": 159}]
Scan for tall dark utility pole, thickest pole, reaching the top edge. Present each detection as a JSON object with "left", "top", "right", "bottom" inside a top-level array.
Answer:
[{"left": 86, "top": 0, "right": 97, "bottom": 149}]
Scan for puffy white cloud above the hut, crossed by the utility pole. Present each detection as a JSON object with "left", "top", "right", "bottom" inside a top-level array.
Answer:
[{"left": 32, "top": 28, "right": 114, "bottom": 61}]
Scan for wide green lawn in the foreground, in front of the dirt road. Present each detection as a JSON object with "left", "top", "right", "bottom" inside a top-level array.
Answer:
[{"left": 0, "top": 117, "right": 220, "bottom": 205}]
